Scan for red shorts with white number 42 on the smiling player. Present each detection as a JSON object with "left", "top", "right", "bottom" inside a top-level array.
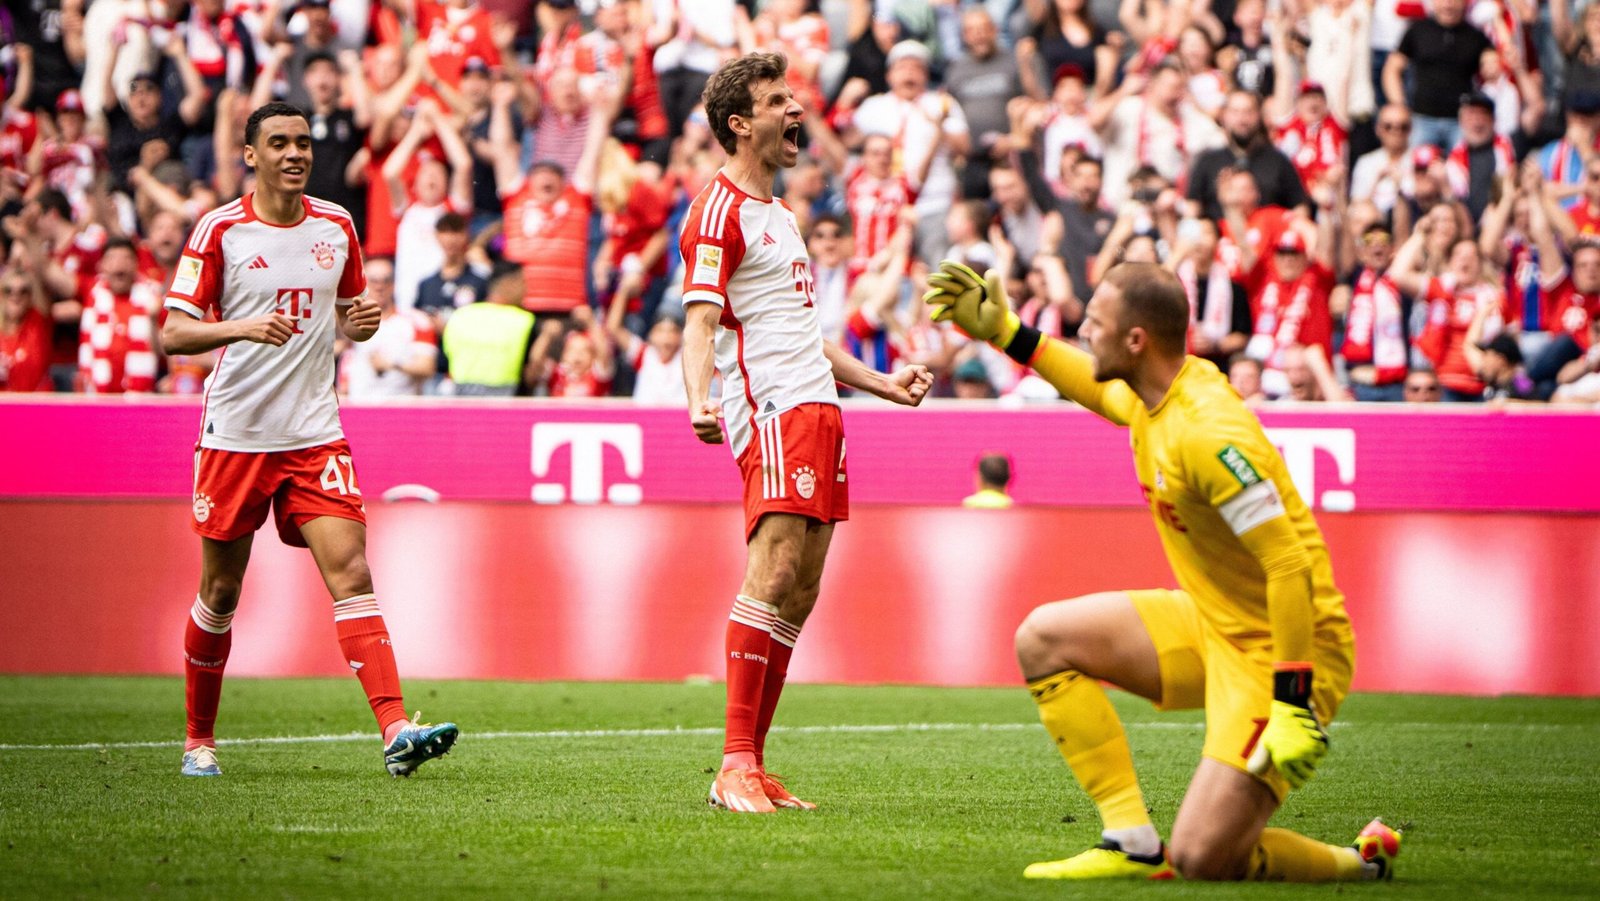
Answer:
[{"left": 194, "top": 438, "right": 366, "bottom": 547}]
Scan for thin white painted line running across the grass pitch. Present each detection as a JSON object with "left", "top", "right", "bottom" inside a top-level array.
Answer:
[{"left": 0, "top": 722, "right": 1594, "bottom": 751}]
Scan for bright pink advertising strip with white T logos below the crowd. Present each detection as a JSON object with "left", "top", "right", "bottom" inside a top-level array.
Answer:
[{"left": 0, "top": 398, "right": 1600, "bottom": 512}]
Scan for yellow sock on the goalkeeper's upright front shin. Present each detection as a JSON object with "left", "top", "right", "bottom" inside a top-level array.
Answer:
[{"left": 1027, "top": 671, "right": 1150, "bottom": 832}]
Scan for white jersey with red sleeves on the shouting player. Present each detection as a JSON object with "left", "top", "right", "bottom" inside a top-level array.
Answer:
[{"left": 678, "top": 173, "right": 838, "bottom": 458}]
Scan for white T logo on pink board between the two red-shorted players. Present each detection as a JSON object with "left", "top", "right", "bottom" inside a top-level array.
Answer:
[{"left": 533, "top": 422, "right": 645, "bottom": 504}]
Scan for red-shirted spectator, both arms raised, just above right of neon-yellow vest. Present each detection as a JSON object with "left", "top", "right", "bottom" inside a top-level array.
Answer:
[{"left": 490, "top": 83, "right": 616, "bottom": 317}]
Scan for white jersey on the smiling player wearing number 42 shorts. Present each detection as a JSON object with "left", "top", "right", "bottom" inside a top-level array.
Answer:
[{"left": 165, "top": 194, "right": 366, "bottom": 453}]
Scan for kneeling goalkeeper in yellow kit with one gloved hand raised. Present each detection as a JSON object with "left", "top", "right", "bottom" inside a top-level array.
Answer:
[{"left": 926, "top": 261, "right": 1400, "bottom": 882}]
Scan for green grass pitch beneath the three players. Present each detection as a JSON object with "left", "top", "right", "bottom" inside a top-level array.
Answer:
[{"left": 0, "top": 677, "right": 1600, "bottom": 901}]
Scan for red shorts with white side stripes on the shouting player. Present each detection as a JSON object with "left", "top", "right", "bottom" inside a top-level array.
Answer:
[{"left": 739, "top": 403, "right": 850, "bottom": 541}]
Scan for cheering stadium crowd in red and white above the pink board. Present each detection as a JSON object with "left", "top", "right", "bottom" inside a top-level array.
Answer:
[{"left": 0, "top": 0, "right": 1600, "bottom": 405}]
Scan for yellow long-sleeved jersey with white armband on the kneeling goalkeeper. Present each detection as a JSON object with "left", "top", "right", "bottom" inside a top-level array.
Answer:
[{"left": 1034, "top": 339, "right": 1352, "bottom": 659}]
